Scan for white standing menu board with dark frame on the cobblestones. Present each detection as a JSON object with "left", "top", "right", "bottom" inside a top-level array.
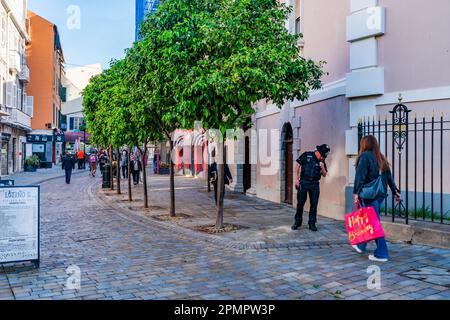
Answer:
[{"left": 0, "top": 186, "right": 40, "bottom": 267}]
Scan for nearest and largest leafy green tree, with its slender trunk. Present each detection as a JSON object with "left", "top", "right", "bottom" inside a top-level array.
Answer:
[{"left": 144, "top": 0, "right": 323, "bottom": 229}]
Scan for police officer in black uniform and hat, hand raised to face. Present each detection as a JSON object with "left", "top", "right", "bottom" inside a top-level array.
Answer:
[{"left": 291, "top": 144, "right": 331, "bottom": 232}]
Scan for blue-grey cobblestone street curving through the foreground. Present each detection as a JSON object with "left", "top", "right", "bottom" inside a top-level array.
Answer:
[{"left": 0, "top": 175, "right": 450, "bottom": 299}]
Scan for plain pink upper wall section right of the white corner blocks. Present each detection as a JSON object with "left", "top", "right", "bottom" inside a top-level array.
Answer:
[{"left": 378, "top": 0, "right": 450, "bottom": 92}]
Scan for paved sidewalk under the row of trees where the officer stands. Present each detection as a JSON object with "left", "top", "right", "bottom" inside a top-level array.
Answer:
[{"left": 96, "top": 174, "right": 348, "bottom": 249}]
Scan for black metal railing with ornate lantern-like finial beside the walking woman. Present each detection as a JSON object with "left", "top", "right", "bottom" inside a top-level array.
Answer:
[{"left": 358, "top": 103, "right": 450, "bottom": 224}]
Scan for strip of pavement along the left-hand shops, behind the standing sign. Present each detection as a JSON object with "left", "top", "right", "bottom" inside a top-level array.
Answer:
[{"left": 2, "top": 164, "right": 87, "bottom": 186}]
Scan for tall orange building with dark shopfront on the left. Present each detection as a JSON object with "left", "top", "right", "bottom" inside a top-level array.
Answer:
[{"left": 26, "top": 11, "right": 66, "bottom": 167}]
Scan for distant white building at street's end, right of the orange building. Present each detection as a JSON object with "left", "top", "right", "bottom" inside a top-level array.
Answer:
[{"left": 62, "top": 64, "right": 102, "bottom": 152}]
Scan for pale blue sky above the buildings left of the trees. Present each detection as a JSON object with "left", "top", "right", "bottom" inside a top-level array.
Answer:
[{"left": 28, "top": 0, "right": 135, "bottom": 69}]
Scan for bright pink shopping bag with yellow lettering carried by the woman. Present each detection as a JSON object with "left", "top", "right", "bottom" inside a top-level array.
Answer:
[{"left": 345, "top": 207, "right": 384, "bottom": 245}]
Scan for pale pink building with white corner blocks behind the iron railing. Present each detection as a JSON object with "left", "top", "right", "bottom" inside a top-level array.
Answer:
[{"left": 225, "top": 0, "right": 450, "bottom": 219}]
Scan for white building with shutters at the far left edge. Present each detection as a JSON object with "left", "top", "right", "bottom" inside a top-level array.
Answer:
[{"left": 0, "top": 0, "right": 33, "bottom": 176}]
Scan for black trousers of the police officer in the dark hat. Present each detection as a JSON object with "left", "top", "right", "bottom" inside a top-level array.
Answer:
[{"left": 295, "top": 181, "right": 320, "bottom": 224}]
